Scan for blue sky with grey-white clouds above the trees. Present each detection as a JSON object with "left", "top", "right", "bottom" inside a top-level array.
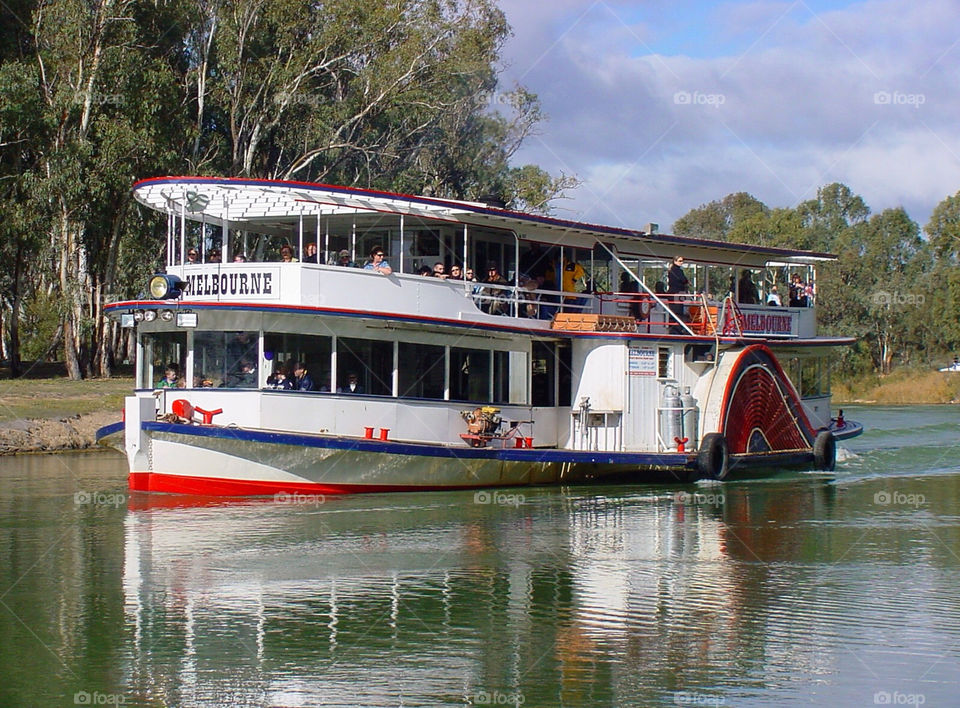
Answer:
[{"left": 499, "top": 0, "right": 960, "bottom": 232}]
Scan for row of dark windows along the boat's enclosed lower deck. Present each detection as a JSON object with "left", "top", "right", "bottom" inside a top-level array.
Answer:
[{"left": 139, "top": 331, "right": 570, "bottom": 406}]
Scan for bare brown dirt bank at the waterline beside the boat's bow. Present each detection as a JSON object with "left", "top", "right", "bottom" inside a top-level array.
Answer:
[{"left": 0, "top": 410, "right": 120, "bottom": 455}]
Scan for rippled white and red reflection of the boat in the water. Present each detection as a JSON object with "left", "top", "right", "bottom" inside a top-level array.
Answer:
[{"left": 123, "top": 480, "right": 856, "bottom": 705}]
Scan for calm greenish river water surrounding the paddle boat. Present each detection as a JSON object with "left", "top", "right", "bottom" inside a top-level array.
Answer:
[{"left": 0, "top": 406, "right": 960, "bottom": 707}]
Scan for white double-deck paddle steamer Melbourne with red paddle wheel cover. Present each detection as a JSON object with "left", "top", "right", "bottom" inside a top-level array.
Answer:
[{"left": 98, "top": 177, "right": 859, "bottom": 495}]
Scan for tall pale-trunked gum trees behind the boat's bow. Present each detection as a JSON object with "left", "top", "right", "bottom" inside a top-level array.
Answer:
[{"left": 0, "top": 0, "right": 575, "bottom": 378}]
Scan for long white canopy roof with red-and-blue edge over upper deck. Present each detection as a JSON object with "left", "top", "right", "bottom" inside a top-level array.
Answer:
[{"left": 133, "top": 177, "right": 835, "bottom": 267}]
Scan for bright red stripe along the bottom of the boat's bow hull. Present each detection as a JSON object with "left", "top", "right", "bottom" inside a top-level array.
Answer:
[{"left": 129, "top": 472, "right": 477, "bottom": 497}]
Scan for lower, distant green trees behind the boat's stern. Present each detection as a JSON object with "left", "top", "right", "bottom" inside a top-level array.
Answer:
[{"left": 674, "top": 183, "right": 960, "bottom": 376}]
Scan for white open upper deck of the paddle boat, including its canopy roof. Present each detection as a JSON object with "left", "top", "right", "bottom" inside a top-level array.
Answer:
[{"left": 124, "top": 177, "right": 840, "bottom": 343}]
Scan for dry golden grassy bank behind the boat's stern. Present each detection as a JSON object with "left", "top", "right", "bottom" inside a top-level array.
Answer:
[{"left": 833, "top": 369, "right": 960, "bottom": 405}]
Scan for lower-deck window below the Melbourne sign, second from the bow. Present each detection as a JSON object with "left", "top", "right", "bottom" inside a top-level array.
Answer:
[{"left": 193, "top": 331, "right": 260, "bottom": 388}]
